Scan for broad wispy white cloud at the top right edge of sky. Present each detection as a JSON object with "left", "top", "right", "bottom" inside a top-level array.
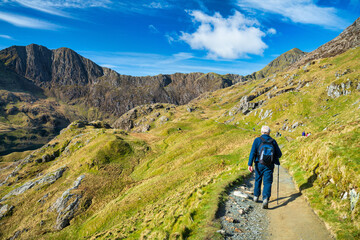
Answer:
[{"left": 238, "top": 0, "right": 346, "bottom": 28}]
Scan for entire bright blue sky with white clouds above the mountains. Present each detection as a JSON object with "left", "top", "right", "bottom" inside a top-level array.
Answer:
[{"left": 0, "top": 0, "right": 360, "bottom": 76}]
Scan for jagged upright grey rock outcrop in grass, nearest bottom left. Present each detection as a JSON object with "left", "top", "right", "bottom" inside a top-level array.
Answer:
[{"left": 49, "top": 175, "right": 85, "bottom": 230}]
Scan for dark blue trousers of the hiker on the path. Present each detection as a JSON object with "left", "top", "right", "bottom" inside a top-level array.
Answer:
[{"left": 254, "top": 162, "right": 274, "bottom": 199}]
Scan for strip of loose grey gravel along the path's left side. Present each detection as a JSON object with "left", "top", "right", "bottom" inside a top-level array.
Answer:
[{"left": 218, "top": 175, "right": 268, "bottom": 240}]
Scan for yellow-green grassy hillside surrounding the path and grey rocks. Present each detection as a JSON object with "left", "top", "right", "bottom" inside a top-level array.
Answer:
[{"left": 0, "top": 48, "right": 360, "bottom": 239}]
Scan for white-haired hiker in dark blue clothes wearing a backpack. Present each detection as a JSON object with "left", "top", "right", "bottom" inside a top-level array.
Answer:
[{"left": 248, "top": 126, "right": 282, "bottom": 209}]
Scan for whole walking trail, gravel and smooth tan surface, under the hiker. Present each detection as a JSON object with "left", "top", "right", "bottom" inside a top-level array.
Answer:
[{"left": 218, "top": 167, "right": 333, "bottom": 240}]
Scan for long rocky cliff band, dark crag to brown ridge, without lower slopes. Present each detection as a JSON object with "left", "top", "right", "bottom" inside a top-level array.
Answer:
[{"left": 0, "top": 44, "right": 245, "bottom": 116}]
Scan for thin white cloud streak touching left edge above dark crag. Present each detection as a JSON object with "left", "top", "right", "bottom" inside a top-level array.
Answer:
[{"left": 0, "top": 12, "right": 60, "bottom": 30}]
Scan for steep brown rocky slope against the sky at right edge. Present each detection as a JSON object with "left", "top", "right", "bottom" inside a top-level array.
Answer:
[{"left": 290, "top": 17, "right": 360, "bottom": 69}]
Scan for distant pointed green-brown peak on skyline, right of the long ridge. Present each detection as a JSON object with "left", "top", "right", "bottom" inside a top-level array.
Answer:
[{"left": 245, "top": 48, "right": 306, "bottom": 79}]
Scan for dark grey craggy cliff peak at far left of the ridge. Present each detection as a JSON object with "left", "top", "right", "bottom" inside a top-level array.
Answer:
[{"left": 0, "top": 44, "right": 103, "bottom": 87}]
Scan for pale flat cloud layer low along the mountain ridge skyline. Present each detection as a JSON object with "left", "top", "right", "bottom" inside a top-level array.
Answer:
[{"left": 79, "top": 51, "right": 266, "bottom": 76}]
